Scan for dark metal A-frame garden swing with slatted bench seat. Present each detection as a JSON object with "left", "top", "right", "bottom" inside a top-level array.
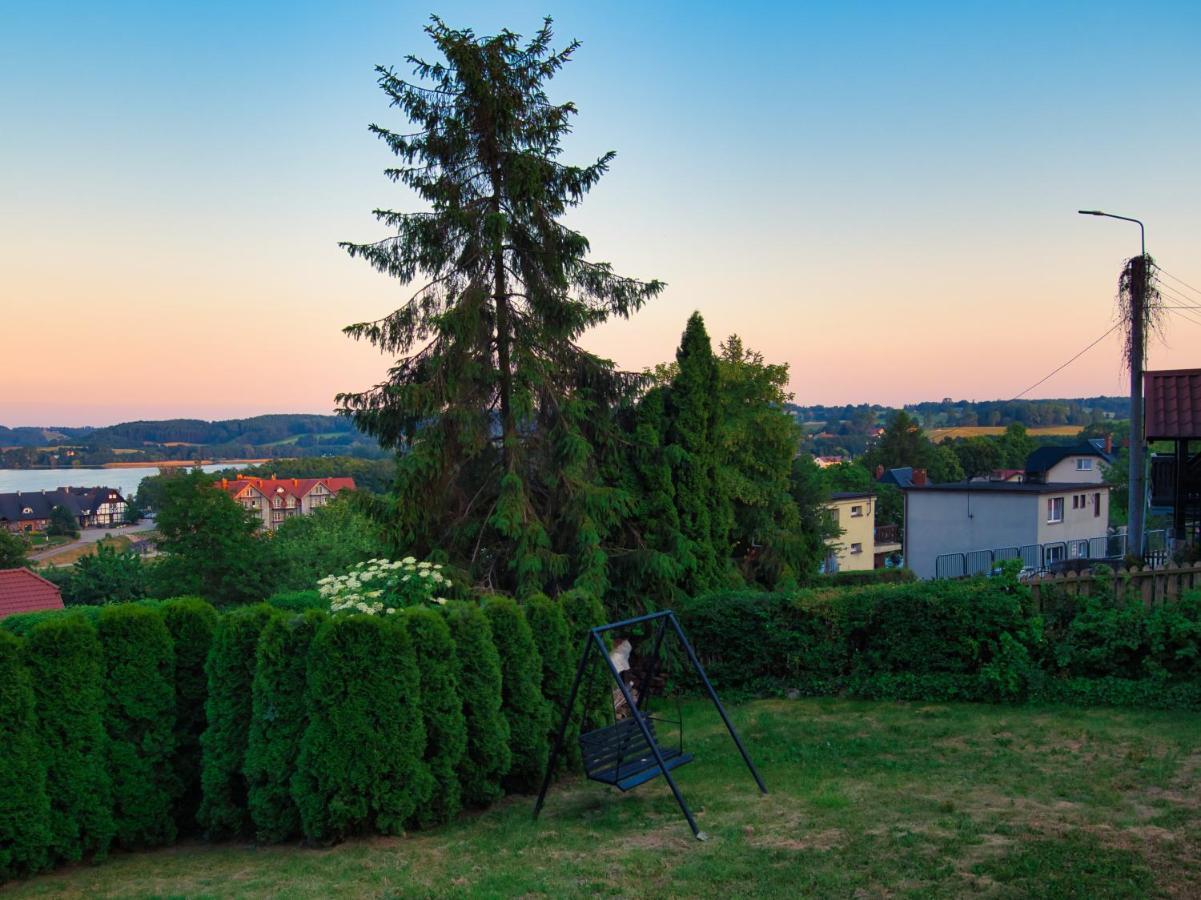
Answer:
[{"left": 533, "top": 609, "right": 767, "bottom": 840}]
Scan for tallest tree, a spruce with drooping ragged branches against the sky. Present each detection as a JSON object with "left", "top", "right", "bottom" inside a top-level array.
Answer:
[{"left": 339, "top": 18, "right": 663, "bottom": 594}]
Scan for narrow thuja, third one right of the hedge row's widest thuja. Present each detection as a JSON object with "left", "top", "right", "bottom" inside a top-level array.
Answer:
[{"left": 484, "top": 597, "right": 550, "bottom": 793}]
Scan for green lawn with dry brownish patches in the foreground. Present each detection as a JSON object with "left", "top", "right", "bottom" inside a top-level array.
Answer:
[{"left": 11, "top": 699, "right": 1201, "bottom": 898}]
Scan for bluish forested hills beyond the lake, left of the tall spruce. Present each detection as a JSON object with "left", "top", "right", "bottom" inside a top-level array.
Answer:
[{"left": 0, "top": 413, "right": 386, "bottom": 469}]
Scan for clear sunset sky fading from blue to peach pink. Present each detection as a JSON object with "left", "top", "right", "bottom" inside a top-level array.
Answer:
[{"left": 0, "top": 0, "right": 1201, "bottom": 425}]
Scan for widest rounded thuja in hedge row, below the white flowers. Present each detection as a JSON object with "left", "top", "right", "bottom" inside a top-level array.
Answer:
[{"left": 293, "top": 615, "right": 434, "bottom": 842}]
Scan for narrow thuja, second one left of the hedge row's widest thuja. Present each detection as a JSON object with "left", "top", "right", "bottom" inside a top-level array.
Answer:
[{"left": 197, "top": 603, "right": 277, "bottom": 838}]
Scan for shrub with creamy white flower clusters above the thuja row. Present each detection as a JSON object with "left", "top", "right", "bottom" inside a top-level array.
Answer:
[{"left": 317, "top": 556, "right": 452, "bottom": 615}]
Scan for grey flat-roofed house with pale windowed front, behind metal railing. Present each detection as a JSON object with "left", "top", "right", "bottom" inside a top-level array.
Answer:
[{"left": 903, "top": 481, "right": 1110, "bottom": 578}]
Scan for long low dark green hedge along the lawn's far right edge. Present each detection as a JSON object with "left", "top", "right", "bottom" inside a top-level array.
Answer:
[{"left": 677, "top": 577, "right": 1201, "bottom": 709}]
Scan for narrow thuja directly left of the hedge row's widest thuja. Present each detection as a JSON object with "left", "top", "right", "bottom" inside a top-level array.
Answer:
[{"left": 244, "top": 609, "right": 327, "bottom": 844}]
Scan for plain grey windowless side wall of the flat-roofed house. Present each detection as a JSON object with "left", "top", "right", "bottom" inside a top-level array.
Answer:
[{"left": 904, "top": 490, "right": 1042, "bottom": 578}]
